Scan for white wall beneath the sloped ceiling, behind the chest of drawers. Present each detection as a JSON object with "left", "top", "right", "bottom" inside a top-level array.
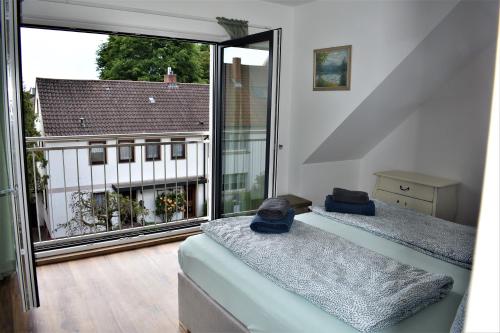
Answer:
[{"left": 359, "top": 45, "right": 495, "bottom": 225}]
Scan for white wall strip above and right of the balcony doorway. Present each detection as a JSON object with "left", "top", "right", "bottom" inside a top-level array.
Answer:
[{"left": 22, "top": 0, "right": 294, "bottom": 193}]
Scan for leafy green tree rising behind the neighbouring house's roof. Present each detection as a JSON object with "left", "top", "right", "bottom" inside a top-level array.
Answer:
[{"left": 96, "top": 36, "right": 210, "bottom": 83}]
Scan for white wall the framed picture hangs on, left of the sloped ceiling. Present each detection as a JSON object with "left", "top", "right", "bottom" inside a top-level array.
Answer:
[{"left": 289, "top": 1, "right": 455, "bottom": 197}]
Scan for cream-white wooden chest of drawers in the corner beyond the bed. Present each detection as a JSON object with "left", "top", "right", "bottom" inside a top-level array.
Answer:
[{"left": 373, "top": 170, "right": 459, "bottom": 221}]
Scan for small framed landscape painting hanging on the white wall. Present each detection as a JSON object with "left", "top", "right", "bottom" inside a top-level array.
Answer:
[{"left": 313, "top": 45, "right": 352, "bottom": 90}]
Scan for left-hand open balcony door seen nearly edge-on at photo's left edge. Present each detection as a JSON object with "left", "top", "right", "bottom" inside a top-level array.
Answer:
[{"left": 0, "top": 0, "right": 38, "bottom": 310}]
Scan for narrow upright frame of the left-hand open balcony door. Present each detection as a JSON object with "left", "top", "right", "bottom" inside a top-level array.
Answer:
[{"left": 0, "top": 0, "right": 40, "bottom": 311}]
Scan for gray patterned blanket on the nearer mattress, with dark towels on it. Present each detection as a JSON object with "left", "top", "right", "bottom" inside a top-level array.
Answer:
[{"left": 202, "top": 217, "right": 453, "bottom": 332}]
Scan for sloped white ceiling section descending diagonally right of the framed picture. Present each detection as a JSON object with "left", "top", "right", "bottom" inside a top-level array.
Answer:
[{"left": 305, "top": 1, "right": 498, "bottom": 164}]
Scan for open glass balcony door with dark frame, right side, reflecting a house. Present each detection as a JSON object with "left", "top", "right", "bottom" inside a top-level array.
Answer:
[{"left": 212, "top": 30, "right": 281, "bottom": 218}]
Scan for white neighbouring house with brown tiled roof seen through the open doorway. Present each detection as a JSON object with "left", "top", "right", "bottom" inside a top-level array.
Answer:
[{"left": 35, "top": 75, "right": 210, "bottom": 238}]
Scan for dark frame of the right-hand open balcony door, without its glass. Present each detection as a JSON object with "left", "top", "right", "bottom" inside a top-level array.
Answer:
[{"left": 210, "top": 29, "right": 281, "bottom": 220}]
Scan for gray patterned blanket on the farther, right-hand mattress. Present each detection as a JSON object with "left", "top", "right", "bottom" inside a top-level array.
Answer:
[{"left": 312, "top": 200, "right": 476, "bottom": 269}]
